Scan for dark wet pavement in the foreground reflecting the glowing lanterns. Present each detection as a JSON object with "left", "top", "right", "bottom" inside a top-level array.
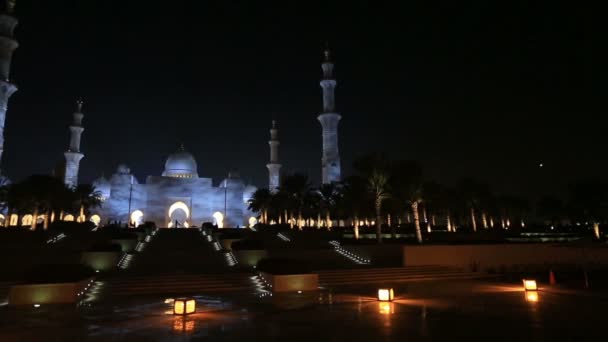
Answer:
[{"left": 0, "top": 281, "right": 608, "bottom": 342}]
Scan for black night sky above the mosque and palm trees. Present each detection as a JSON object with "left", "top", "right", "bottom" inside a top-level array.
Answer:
[{"left": 3, "top": 0, "right": 608, "bottom": 198}]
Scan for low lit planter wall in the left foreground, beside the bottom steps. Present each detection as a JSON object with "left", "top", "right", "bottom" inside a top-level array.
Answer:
[{"left": 8, "top": 278, "right": 92, "bottom": 305}]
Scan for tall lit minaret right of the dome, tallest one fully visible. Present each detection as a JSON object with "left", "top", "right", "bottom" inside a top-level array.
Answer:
[{"left": 318, "top": 48, "right": 342, "bottom": 184}]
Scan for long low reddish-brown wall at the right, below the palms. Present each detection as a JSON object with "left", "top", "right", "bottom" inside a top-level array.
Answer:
[{"left": 403, "top": 244, "right": 608, "bottom": 271}]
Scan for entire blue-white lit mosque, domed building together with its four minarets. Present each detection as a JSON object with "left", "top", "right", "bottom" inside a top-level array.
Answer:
[{"left": 0, "top": 1, "right": 341, "bottom": 228}]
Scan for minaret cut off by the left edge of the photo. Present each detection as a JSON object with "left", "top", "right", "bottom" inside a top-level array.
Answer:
[{"left": 0, "top": 0, "right": 19, "bottom": 170}]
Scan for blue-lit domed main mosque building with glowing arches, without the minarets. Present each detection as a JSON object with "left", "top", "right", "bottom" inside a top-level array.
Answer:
[{"left": 93, "top": 147, "right": 255, "bottom": 228}]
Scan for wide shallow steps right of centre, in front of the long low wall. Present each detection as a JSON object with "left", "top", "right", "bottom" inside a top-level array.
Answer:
[{"left": 317, "top": 265, "right": 488, "bottom": 287}]
